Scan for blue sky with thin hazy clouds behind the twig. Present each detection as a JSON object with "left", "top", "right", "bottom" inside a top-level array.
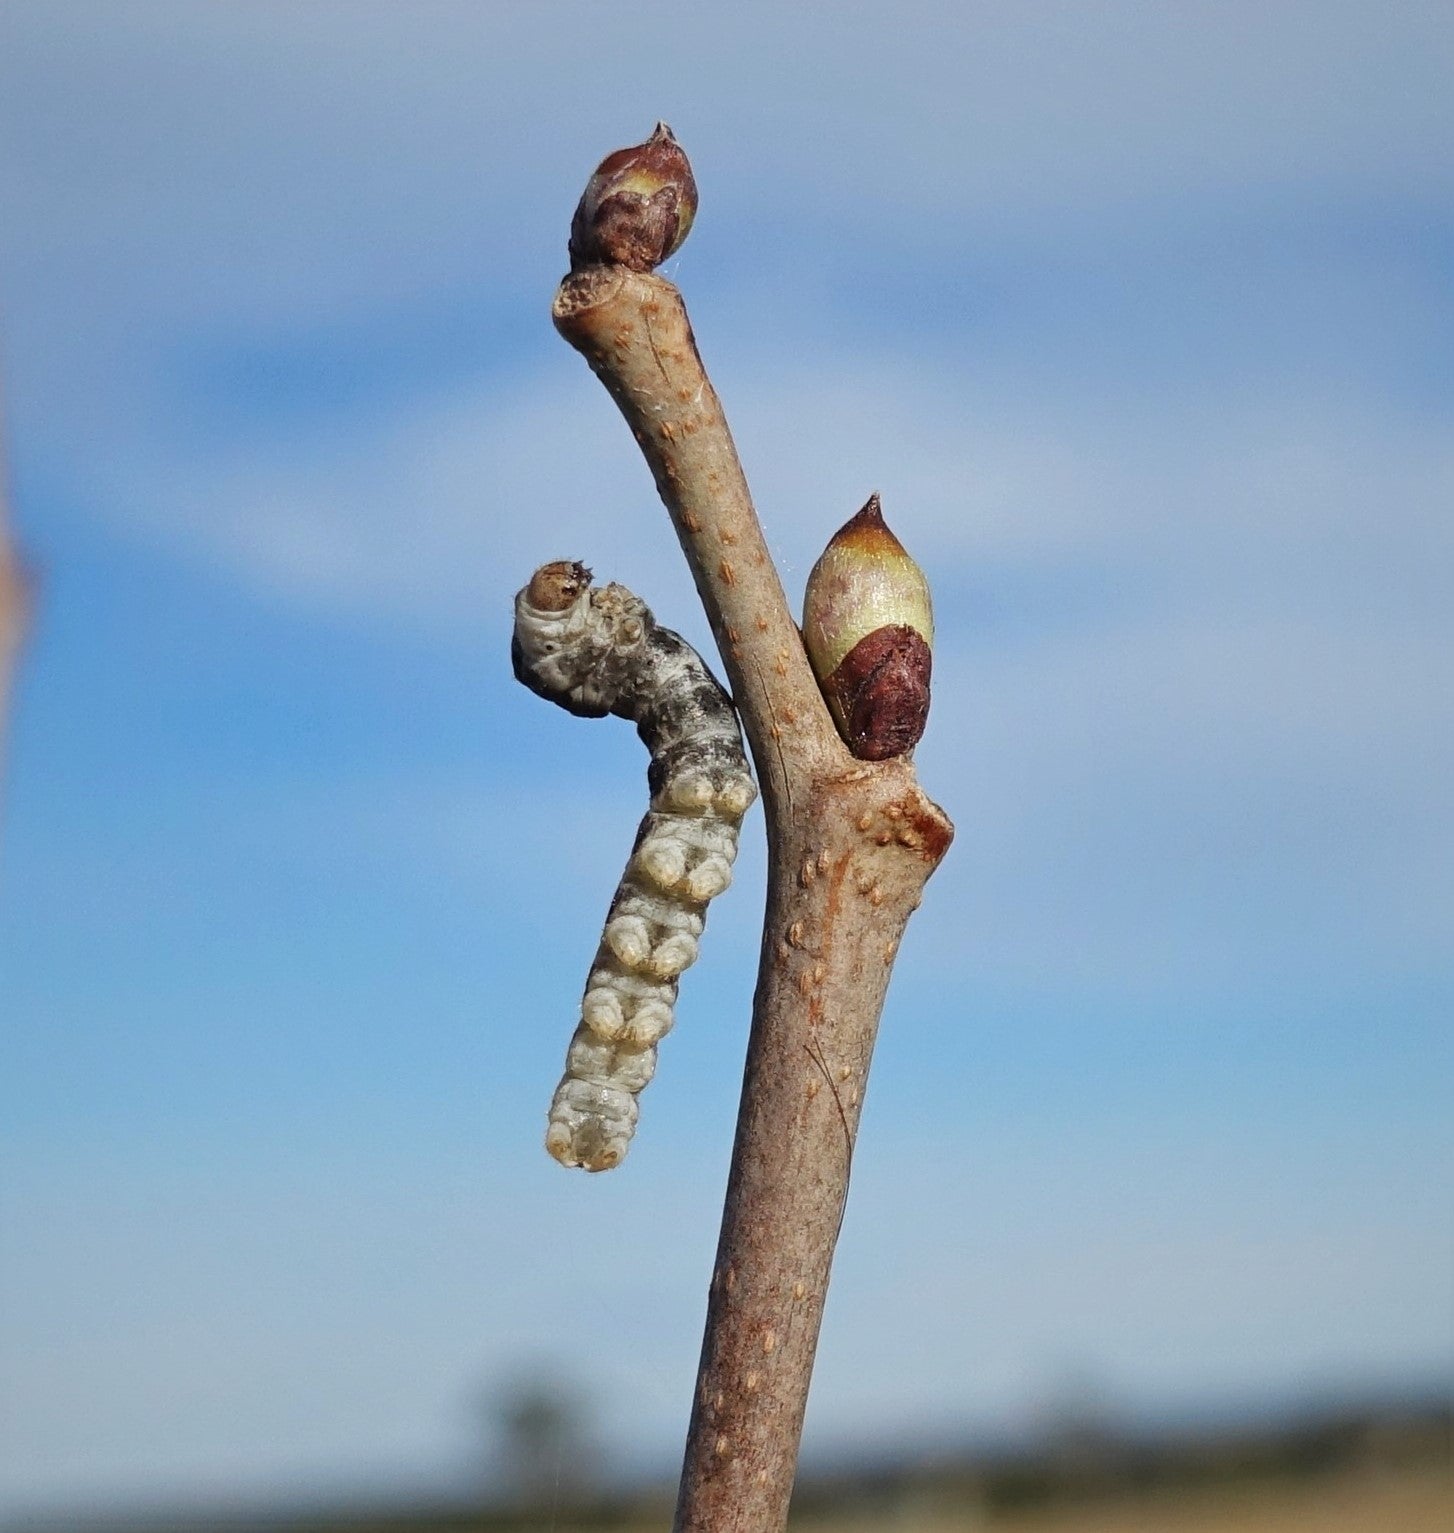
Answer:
[{"left": 0, "top": 0, "right": 1454, "bottom": 1508}]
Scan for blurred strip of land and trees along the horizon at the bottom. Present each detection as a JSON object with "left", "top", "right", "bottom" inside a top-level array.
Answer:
[{"left": 5, "top": 1375, "right": 1454, "bottom": 1533}]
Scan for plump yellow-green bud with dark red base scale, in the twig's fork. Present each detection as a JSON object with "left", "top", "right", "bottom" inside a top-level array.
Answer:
[{"left": 802, "top": 495, "right": 934, "bottom": 762}]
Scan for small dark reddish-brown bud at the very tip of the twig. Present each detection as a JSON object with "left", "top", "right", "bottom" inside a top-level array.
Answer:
[{"left": 571, "top": 123, "right": 696, "bottom": 271}]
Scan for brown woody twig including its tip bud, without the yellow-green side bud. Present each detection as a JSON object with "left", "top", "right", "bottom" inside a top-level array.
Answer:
[{"left": 554, "top": 127, "right": 952, "bottom": 1533}]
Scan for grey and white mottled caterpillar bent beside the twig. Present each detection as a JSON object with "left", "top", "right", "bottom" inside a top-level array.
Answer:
[{"left": 511, "top": 561, "right": 758, "bottom": 1171}]
